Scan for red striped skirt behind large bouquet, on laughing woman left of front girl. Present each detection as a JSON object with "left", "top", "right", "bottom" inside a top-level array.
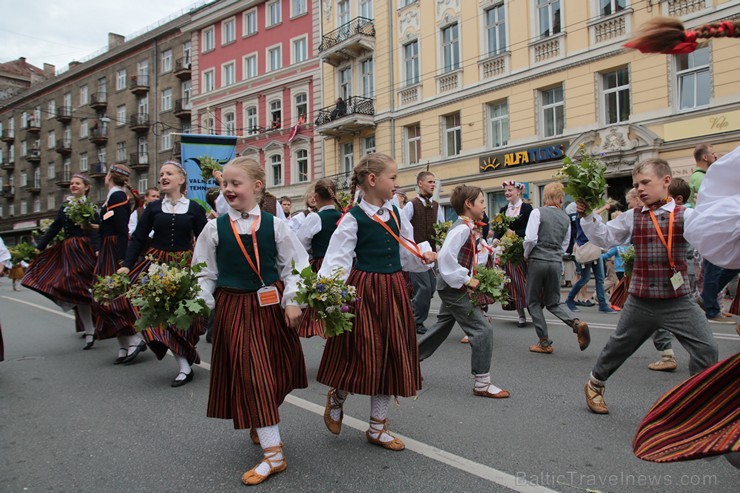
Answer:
[{"left": 126, "top": 248, "right": 205, "bottom": 365}]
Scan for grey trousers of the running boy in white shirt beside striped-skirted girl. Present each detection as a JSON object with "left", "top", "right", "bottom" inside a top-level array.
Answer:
[{"left": 419, "top": 289, "right": 493, "bottom": 375}]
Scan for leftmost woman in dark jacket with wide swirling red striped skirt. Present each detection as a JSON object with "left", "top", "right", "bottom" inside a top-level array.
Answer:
[{"left": 21, "top": 173, "right": 99, "bottom": 349}]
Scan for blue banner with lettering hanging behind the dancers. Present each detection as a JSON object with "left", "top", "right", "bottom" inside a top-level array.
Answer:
[{"left": 180, "top": 134, "right": 236, "bottom": 211}]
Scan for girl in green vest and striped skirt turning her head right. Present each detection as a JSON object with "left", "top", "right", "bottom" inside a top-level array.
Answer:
[{"left": 317, "top": 154, "right": 436, "bottom": 450}]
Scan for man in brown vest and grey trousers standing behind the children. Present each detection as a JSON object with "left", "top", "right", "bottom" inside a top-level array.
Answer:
[{"left": 403, "top": 171, "right": 445, "bottom": 334}]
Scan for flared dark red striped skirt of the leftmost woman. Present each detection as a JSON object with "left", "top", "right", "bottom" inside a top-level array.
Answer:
[{"left": 21, "top": 237, "right": 95, "bottom": 310}]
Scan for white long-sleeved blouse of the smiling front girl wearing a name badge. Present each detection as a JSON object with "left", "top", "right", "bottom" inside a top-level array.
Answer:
[{"left": 193, "top": 207, "right": 308, "bottom": 309}]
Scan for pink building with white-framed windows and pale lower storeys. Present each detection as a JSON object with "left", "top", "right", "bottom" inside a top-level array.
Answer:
[{"left": 186, "top": 0, "right": 323, "bottom": 210}]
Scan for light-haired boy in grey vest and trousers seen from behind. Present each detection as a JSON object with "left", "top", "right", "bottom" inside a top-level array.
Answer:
[{"left": 524, "top": 182, "right": 591, "bottom": 354}]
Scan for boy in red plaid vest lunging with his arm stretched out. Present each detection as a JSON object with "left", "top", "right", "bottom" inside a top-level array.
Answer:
[{"left": 578, "top": 159, "right": 717, "bottom": 414}]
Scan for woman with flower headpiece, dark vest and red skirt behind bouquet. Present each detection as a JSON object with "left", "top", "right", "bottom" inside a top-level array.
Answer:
[{"left": 499, "top": 180, "right": 532, "bottom": 327}]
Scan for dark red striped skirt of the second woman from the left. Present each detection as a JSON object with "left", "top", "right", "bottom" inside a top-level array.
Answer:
[{"left": 95, "top": 236, "right": 136, "bottom": 339}]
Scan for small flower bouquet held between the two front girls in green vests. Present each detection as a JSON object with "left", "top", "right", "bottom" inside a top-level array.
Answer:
[{"left": 293, "top": 264, "right": 357, "bottom": 338}]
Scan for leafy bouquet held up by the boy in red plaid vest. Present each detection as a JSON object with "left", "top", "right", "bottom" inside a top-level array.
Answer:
[{"left": 555, "top": 144, "right": 606, "bottom": 209}]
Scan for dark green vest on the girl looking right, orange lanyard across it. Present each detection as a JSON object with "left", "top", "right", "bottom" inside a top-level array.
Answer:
[{"left": 349, "top": 205, "right": 402, "bottom": 274}]
